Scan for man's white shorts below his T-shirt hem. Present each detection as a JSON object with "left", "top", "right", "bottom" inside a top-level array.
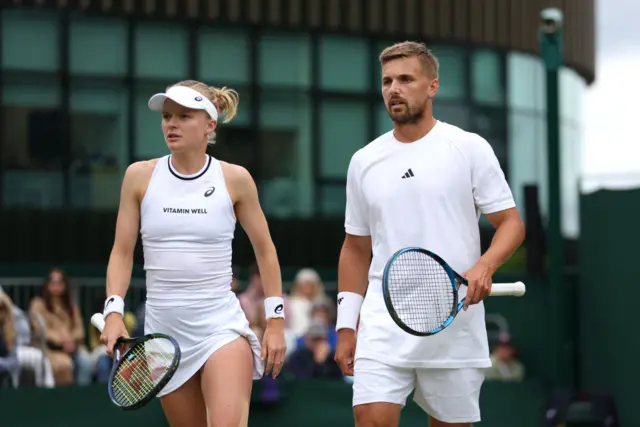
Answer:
[{"left": 353, "top": 358, "right": 484, "bottom": 423}]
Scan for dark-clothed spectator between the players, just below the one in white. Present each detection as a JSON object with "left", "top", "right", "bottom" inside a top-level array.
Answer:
[{"left": 285, "top": 322, "right": 342, "bottom": 379}]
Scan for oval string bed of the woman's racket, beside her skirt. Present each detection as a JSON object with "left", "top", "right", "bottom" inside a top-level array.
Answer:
[{"left": 112, "top": 338, "right": 175, "bottom": 406}]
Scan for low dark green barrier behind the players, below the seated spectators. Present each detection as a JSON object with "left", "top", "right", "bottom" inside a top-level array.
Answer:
[{"left": 0, "top": 380, "right": 544, "bottom": 427}]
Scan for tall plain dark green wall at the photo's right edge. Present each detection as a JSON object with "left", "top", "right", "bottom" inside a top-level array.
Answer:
[{"left": 578, "top": 190, "right": 640, "bottom": 426}]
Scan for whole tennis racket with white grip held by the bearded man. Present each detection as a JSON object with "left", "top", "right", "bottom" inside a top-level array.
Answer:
[{"left": 382, "top": 248, "right": 525, "bottom": 337}]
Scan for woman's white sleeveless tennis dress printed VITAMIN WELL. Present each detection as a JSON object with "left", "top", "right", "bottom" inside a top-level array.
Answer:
[{"left": 140, "top": 155, "right": 264, "bottom": 397}]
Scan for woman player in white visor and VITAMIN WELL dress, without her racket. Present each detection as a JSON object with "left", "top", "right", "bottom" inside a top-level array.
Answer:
[{"left": 101, "top": 80, "right": 285, "bottom": 427}]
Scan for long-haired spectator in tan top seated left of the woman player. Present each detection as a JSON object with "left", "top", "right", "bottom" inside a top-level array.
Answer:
[{"left": 29, "top": 268, "right": 94, "bottom": 386}]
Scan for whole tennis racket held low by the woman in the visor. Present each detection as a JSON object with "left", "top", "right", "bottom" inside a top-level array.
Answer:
[{"left": 91, "top": 313, "right": 181, "bottom": 411}]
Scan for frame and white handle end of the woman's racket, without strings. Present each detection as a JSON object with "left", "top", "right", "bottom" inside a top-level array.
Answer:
[{"left": 91, "top": 313, "right": 182, "bottom": 411}]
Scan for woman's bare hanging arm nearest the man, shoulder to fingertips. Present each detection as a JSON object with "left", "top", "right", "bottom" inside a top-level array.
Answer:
[{"left": 225, "top": 164, "right": 286, "bottom": 378}]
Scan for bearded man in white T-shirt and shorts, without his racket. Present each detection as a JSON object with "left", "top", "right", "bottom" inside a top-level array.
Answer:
[{"left": 336, "top": 42, "right": 524, "bottom": 427}]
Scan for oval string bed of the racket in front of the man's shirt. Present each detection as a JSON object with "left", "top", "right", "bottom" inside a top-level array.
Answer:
[{"left": 388, "top": 251, "right": 455, "bottom": 333}]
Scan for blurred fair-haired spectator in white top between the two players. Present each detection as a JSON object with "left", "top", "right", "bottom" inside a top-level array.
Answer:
[{"left": 289, "top": 268, "right": 327, "bottom": 337}]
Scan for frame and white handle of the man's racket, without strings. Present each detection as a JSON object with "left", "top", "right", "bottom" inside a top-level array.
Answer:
[{"left": 382, "top": 247, "right": 525, "bottom": 337}]
